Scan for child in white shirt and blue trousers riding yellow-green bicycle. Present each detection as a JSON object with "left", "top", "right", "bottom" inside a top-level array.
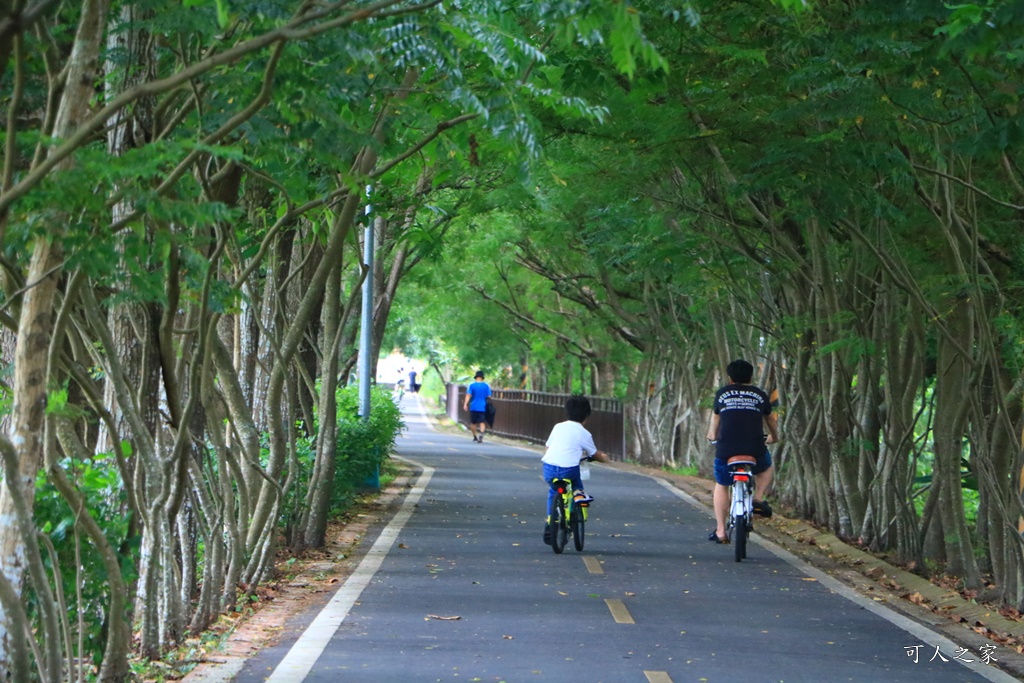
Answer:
[{"left": 541, "top": 396, "right": 609, "bottom": 545}]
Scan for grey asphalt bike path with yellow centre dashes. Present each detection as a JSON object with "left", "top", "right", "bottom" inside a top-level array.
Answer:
[{"left": 237, "top": 396, "right": 1015, "bottom": 683}]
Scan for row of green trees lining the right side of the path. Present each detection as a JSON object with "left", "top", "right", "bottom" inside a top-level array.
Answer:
[{"left": 399, "top": 2, "right": 1024, "bottom": 605}]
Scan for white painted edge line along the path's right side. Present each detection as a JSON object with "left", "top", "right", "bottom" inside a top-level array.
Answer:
[{"left": 651, "top": 474, "right": 1020, "bottom": 683}]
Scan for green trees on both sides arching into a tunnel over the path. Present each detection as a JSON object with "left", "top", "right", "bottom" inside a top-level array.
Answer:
[{"left": 0, "top": 0, "right": 1024, "bottom": 681}]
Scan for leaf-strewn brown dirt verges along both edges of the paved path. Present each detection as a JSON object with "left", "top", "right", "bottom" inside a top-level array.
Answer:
[{"left": 180, "top": 424, "right": 1024, "bottom": 683}]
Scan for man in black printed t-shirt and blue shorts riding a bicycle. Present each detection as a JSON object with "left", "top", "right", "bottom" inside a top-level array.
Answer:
[{"left": 708, "top": 359, "right": 778, "bottom": 543}]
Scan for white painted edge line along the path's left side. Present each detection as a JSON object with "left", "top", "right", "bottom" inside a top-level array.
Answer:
[{"left": 266, "top": 456, "right": 434, "bottom": 683}]
